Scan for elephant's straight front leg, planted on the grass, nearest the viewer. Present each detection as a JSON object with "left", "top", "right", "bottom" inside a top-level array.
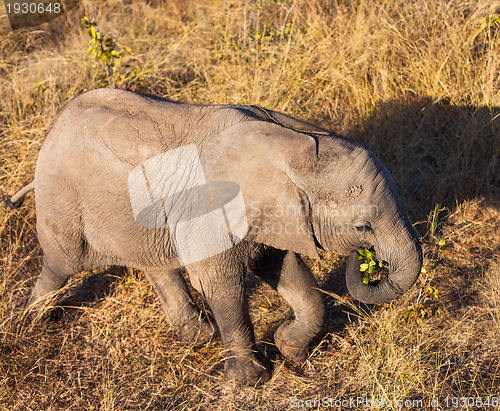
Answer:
[{"left": 187, "top": 258, "right": 270, "bottom": 385}]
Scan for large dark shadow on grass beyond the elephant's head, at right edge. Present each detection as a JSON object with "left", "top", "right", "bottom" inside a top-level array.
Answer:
[{"left": 347, "top": 97, "right": 500, "bottom": 229}]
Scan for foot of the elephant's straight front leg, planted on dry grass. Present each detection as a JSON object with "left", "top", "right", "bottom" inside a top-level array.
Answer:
[{"left": 224, "top": 352, "right": 271, "bottom": 385}]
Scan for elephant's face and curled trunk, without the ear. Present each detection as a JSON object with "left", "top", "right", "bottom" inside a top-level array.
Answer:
[{"left": 302, "top": 138, "right": 422, "bottom": 304}]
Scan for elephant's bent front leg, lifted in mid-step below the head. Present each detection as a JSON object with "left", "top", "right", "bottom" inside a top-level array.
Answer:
[{"left": 254, "top": 249, "right": 325, "bottom": 363}]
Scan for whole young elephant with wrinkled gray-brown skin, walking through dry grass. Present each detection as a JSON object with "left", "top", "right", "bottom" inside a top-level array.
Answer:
[{"left": 24, "top": 89, "right": 422, "bottom": 384}]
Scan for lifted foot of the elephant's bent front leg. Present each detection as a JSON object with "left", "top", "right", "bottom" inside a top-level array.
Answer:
[{"left": 274, "top": 320, "right": 310, "bottom": 363}]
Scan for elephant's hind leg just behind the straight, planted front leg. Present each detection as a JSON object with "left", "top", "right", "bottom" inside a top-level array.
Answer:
[{"left": 146, "top": 270, "right": 215, "bottom": 345}]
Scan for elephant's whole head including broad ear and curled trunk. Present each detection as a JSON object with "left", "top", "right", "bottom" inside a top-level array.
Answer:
[{"left": 215, "top": 122, "right": 422, "bottom": 303}]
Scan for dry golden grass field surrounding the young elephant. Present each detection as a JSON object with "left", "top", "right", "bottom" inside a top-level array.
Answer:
[{"left": 0, "top": 0, "right": 500, "bottom": 411}]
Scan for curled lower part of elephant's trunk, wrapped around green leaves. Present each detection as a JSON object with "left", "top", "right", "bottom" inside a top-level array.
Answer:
[{"left": 346, "top": 230, "right": 422, "bottom": 304}]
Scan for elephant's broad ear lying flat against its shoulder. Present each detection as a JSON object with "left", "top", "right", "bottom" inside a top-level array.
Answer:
[{"left": 202, "top": 121, "right": 319, "bottom": 259}]
